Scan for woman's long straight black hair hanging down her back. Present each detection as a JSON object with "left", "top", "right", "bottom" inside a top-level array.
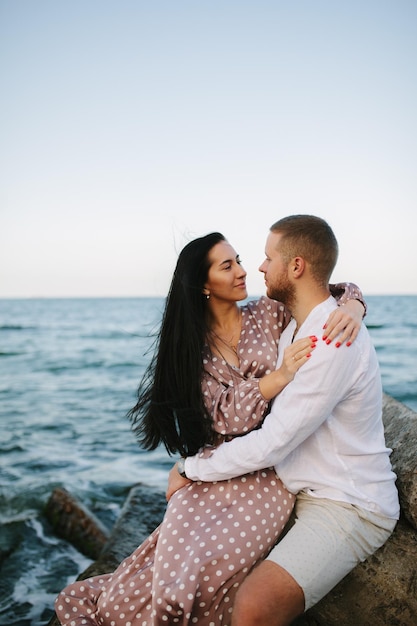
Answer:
[{"left": 128, "top": 233, "right": 225, "bottom": 456}]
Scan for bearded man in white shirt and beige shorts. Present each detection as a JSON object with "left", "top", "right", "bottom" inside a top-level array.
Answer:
[{"left": 167, "top": 215, "right": 399, "bottom": 626}]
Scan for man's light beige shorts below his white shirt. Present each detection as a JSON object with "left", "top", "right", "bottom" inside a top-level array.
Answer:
[{"left": 267, "top": 492, "right": 397, "bottom": 610}]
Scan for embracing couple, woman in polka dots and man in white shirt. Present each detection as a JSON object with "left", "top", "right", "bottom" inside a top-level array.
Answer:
[{"left": 55, "top": 215, "right": 399, "bottom": 626}]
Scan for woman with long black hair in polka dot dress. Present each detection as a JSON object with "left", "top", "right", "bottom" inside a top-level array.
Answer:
[{"left": 56, "top": 233, "right": 363, "bottom": 626}]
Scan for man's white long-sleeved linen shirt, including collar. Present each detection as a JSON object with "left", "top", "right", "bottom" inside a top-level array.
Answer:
[{"left": 185, "top": 296, "right": 399, "bottom": 519}]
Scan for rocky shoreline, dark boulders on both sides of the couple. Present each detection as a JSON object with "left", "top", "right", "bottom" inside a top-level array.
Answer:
[{"left": 46, "top": 395, "right": 417, "bottom": 626}]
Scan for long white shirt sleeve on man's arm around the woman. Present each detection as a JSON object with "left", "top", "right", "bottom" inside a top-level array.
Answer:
[{"left": 185, "top": 334, "right": 360, "bottom": 481}]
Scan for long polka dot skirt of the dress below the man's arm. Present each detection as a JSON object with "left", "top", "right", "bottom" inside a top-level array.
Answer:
[{"left": 55, "top": 469, "right": 294, "bottom": 626}]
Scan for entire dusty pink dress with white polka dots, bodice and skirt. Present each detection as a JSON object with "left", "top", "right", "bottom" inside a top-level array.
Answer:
[{"left": 55, "top": 298, "right": 294, "bottom": 626}]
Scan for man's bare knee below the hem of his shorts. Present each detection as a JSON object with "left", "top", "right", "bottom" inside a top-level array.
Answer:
[{"left": 232, "top": 561, "right": 304, "bottom": 626}]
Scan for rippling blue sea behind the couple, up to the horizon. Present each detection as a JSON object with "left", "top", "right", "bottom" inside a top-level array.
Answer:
[{"left": 0, "top": 295, "right": 417, "bottom": 626}]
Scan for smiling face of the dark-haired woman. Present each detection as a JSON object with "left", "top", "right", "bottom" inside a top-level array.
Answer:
[{"left": 204, "top": 241, "right": 248, "bottom": 302}]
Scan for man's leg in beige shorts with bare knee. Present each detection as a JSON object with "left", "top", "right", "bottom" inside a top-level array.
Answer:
[{"left": 232, "top": 493, "right": 396, "bottom": 626}]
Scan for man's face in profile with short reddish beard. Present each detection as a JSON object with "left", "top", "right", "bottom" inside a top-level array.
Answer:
[{"left": 259, "top": 232, "right": 295, "bottom": 306}]
